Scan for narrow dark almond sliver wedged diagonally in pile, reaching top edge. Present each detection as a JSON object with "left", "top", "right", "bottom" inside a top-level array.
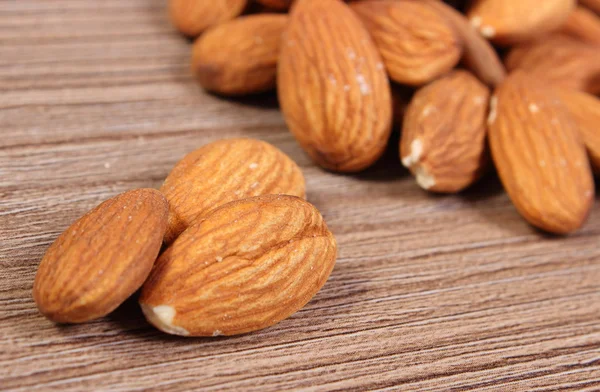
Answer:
[{"left": 421, "top": 0, "right": 506, "bottom": 87}]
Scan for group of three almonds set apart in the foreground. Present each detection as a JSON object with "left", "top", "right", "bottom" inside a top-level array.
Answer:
[{"left": 33, "top": 139, "right": 337, "bottom": 336}]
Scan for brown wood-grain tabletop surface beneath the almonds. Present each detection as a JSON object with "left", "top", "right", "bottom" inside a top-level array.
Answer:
[{"left": 0, "top": 0, "right": 600, "bottom": 392}]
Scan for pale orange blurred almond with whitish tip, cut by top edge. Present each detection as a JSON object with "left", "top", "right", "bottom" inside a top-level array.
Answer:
[{"left": 467, "top": 0, "right": 576, "bottom": 45}]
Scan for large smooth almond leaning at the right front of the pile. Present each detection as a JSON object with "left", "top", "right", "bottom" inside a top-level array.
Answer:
[{"left": 489, "top": 71, "right": 594, "bottom": 234}]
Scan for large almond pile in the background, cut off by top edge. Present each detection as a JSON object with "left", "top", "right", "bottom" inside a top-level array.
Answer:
[{"left": 180, "top": 0, "right": 600, "bottom": 234}]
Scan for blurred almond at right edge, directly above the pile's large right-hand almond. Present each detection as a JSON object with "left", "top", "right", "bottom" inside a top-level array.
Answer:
[{"left": 506, "top": 35, "right": 600, "bottom": 94}]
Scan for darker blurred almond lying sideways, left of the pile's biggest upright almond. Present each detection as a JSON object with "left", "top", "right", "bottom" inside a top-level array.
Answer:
[{"left": 192, "top": 14, "right": 288, "bottom": 95}]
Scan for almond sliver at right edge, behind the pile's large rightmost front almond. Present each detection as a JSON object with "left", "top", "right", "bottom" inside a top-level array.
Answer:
[{"left": 557, "top": 89, "right": 600, "bottom": 174}]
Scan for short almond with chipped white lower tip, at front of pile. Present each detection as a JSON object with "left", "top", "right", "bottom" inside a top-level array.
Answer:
[{"left": 400, "top": 71, "right": 490, "bottom": 193}]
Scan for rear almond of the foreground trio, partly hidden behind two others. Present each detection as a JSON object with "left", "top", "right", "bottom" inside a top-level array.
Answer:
[{"left": 160, "top": 139, "right": 306, "bottom": 244}]
